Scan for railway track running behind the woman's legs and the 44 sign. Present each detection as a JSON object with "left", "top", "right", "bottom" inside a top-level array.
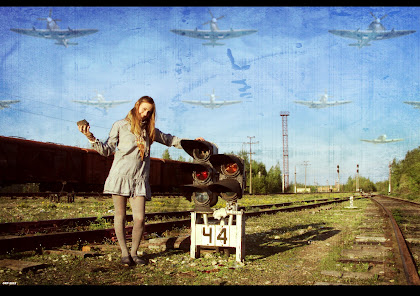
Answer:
[{"left": 0, "top": 197, "right": 358, "bottom": 254}]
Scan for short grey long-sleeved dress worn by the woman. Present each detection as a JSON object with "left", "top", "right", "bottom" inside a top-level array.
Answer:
[{"left": 92, "top": 119, "right": 182, "bottom": 200}]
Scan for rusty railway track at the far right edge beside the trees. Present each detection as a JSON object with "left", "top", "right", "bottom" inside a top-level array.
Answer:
[{"left": 372, "top": 195, "right": 420, "bottom": 285}]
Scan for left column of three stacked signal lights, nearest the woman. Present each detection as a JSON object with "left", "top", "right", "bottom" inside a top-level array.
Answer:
[{"left": 181, "top": 140, "right": 218, "bottom": 212}]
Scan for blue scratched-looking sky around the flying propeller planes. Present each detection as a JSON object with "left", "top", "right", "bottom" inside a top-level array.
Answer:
[{"left": 0, "top": 7, "right": 420, "bottom": 184}]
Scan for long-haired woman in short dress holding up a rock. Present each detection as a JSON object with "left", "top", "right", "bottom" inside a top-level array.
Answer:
[{"left": 79, "top": 96, "right": 204, "bottom": 265}]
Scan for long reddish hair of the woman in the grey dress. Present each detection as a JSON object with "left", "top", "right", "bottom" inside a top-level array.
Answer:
[{"left": 125, "top": 96, "right": 156, "bottom": 145}]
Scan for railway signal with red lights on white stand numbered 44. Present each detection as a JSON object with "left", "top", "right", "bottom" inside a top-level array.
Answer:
[{"left": 181, "top": 140, "right": 246, "bottom": 262}]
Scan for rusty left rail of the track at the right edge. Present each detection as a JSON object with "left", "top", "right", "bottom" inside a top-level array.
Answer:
[{"left": 371, "top": 197, "right": 420, "bottom": 285}]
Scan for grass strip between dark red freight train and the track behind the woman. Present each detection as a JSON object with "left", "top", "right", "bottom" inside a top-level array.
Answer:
[{"left": 0, "top": 193, "right": 349, "bottom": 223}]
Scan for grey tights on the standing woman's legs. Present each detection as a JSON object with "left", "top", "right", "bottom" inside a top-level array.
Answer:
[{"left": 112, "top": 195, "right": 145, "bottom": 257}]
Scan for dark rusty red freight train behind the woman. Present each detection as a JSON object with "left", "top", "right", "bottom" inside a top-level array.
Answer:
[{"left": 0, "top": 136, "right": 192, "bottom": 194}]
